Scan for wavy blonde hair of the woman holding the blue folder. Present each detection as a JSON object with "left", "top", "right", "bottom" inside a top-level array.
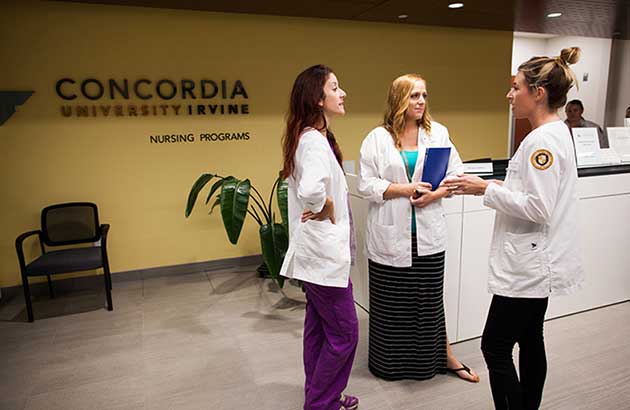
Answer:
[{"left": 383, "top": 74, "right": 431, "bottom": 151}]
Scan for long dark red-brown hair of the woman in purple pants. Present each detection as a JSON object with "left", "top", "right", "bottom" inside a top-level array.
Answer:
[{"left": 280, "top": 64, "right": 343, "bottom": 178}]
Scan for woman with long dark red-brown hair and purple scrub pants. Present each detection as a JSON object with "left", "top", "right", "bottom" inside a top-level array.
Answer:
[{"left": 280, "top": 65, "right": 359, "bottom": 410}]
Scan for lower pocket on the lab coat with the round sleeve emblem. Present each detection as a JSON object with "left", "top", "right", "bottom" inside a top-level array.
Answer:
[{"left": 502, "top": 232, "right": 543, "bottom": 277}]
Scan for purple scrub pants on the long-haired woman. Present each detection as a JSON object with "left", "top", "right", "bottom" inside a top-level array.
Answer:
[{"left": 304, "top": 281, "right": 359, "bottom": 410}]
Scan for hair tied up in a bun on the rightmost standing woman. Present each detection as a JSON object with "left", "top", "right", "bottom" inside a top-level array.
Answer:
[{"left": 518, "top": 47, "right": 581, "bottom": 109}]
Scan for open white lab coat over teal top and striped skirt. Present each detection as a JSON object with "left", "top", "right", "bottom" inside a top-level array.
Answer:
[{"left": 358, "top": 121, "right": 463, "bottom": 267}]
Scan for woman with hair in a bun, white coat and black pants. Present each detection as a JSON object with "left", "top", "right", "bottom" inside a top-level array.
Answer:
[{"left": 444, "top": 47, "right": 583, "bottom": 410}]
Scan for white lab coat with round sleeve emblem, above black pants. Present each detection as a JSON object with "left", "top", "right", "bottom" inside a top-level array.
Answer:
[{"left": 483, "top": 121, "right": 583, "bottom": 298}]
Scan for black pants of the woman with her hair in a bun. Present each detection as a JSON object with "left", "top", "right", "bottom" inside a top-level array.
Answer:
[{"left": 481, "top": 295, "right": 548, "bottom": 410}]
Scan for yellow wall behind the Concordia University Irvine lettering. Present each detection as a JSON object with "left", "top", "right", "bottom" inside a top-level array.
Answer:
[{"left": 0, "top": 1, "right": 512, "bottom": 286}]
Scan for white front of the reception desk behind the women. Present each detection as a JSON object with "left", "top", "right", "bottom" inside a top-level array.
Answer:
[{"left": 348, "top": 168, "right": 630, "bottom": 342}]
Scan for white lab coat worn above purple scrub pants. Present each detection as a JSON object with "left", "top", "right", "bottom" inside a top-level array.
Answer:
[{"left": 280, "top": 128, "right": 350, "bottom": 288}]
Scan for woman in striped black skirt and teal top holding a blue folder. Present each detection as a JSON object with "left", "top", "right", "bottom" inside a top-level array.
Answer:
[{"left": 358, "top": 74, "right": 479, "bottom": 382}]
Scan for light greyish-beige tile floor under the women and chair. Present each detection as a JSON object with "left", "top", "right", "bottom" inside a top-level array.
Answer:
[{"left": 0, "top": 267, "right": 630, "bottom": 410}]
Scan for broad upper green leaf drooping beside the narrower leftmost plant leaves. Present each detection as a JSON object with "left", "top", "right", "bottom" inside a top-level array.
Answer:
[{"left": 219, "top": 178, "right": 251, "bottom": 245}]
